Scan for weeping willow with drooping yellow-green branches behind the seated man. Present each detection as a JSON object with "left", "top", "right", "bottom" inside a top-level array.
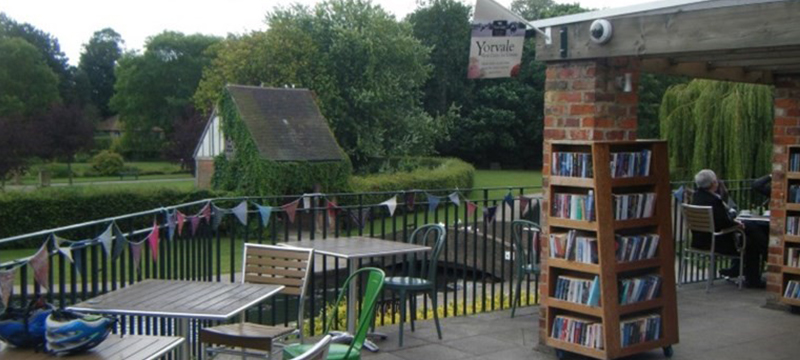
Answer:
[{"left": 659, "top": 80, "right": 773, "bottom": 180}]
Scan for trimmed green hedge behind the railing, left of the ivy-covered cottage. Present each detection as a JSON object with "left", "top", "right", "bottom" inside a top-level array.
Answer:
[{"left": 0, "top": 187, "right": 222, "bottom": 247}]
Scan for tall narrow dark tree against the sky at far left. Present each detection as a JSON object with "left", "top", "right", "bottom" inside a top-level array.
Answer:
[{"left": 78, "top": 28, "right": 123, "bottom": 117}]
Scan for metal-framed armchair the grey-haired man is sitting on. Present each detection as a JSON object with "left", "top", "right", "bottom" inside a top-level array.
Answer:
[{"left": 678, "top": 204, "right": 747, "bottom": 292}]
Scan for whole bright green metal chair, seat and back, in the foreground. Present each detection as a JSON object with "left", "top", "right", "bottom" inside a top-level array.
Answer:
[{"left": 283, "top": 267, "right": 386, "bottom": 360}]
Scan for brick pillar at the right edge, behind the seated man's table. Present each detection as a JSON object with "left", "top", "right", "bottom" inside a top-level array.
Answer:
[{"left": 767, "top": 76, "right": 800, "bottom": 305}]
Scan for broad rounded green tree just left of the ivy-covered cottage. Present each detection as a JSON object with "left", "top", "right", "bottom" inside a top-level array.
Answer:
[{"left": 111, "top": 31, "right": 220, "bottom": 158}]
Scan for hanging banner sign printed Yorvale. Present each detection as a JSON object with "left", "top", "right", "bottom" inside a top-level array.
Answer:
[{"left": 467, "top": 0, "right": 525, "bottom": 79}]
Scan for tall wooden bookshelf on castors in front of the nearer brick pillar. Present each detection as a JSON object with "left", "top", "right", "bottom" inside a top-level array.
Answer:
[{"left": 542, "top": 141, "right": 676, "bottom": 359}]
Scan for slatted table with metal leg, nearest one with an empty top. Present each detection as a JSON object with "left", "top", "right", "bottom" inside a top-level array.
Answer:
[{"left": 68, "top": 280, "right": 283, "bottom": 359}]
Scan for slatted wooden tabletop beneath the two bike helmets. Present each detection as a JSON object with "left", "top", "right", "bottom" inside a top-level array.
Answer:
[{"left": 0, "top": 334, "right": 184, "bottom": 360}]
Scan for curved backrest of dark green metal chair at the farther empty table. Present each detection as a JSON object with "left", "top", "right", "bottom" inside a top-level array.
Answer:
[{"left": 406, "top": 224, "right": 447, "bottom": 282}]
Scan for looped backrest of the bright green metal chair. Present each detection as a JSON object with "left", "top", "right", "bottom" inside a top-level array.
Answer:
[{"left": 325, "top": 267, "right": 386, "bottom": 359}]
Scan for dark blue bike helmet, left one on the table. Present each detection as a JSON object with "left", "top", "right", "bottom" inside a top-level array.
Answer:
[{"left": 0, "top": 299, "right": 53, "bottom": 349}]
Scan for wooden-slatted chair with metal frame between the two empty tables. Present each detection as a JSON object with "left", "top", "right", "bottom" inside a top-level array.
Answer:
[{"left": 199, "top": 243, "right": 314, "bottom": 359}]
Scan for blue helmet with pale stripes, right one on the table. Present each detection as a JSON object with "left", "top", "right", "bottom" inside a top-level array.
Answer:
[{"left": 45, "top": 310, "right": 117, "bottom": 355}]
